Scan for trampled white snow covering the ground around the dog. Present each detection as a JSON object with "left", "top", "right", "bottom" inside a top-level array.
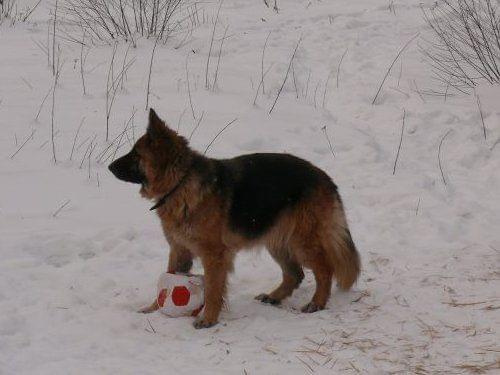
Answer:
[{"left": 0, "top": 0, "right": 500, "bottom": 374}]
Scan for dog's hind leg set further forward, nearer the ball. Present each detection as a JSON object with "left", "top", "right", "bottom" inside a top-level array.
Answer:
[{"left": 255, "top": 250, "right": 304, "bottom": 305}]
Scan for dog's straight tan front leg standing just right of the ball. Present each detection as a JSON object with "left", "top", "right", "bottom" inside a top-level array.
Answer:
[{"left": 193, "top": 252, "right": 232, "bottom": 329}]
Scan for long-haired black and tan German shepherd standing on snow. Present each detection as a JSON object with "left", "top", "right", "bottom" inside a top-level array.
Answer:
[{"left": 109, "top": 109, "right": 360, "bottom": 328}]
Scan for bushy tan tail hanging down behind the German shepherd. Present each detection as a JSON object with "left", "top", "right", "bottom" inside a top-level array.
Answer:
[{"left": 327, "top": 204, "right": 361, "bottom": 290}]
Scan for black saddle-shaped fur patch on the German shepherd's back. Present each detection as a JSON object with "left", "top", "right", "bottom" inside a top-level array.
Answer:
[{"left": 218, "top": 153, "right": 337, "bottom": 239}]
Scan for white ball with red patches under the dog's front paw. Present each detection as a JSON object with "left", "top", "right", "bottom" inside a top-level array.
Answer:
[{"left": 156, "top": 272, "right": 204, "bottom": 317}]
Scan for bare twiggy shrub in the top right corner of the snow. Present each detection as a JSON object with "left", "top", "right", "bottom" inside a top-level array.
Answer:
[{"left": 422, "top": 0, "right": 500, "bottom": 92}]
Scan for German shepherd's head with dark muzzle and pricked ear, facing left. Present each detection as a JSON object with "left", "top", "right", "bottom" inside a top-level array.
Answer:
[{"left": 108, "top": 109, "right": 187, "bottom": 198}]
